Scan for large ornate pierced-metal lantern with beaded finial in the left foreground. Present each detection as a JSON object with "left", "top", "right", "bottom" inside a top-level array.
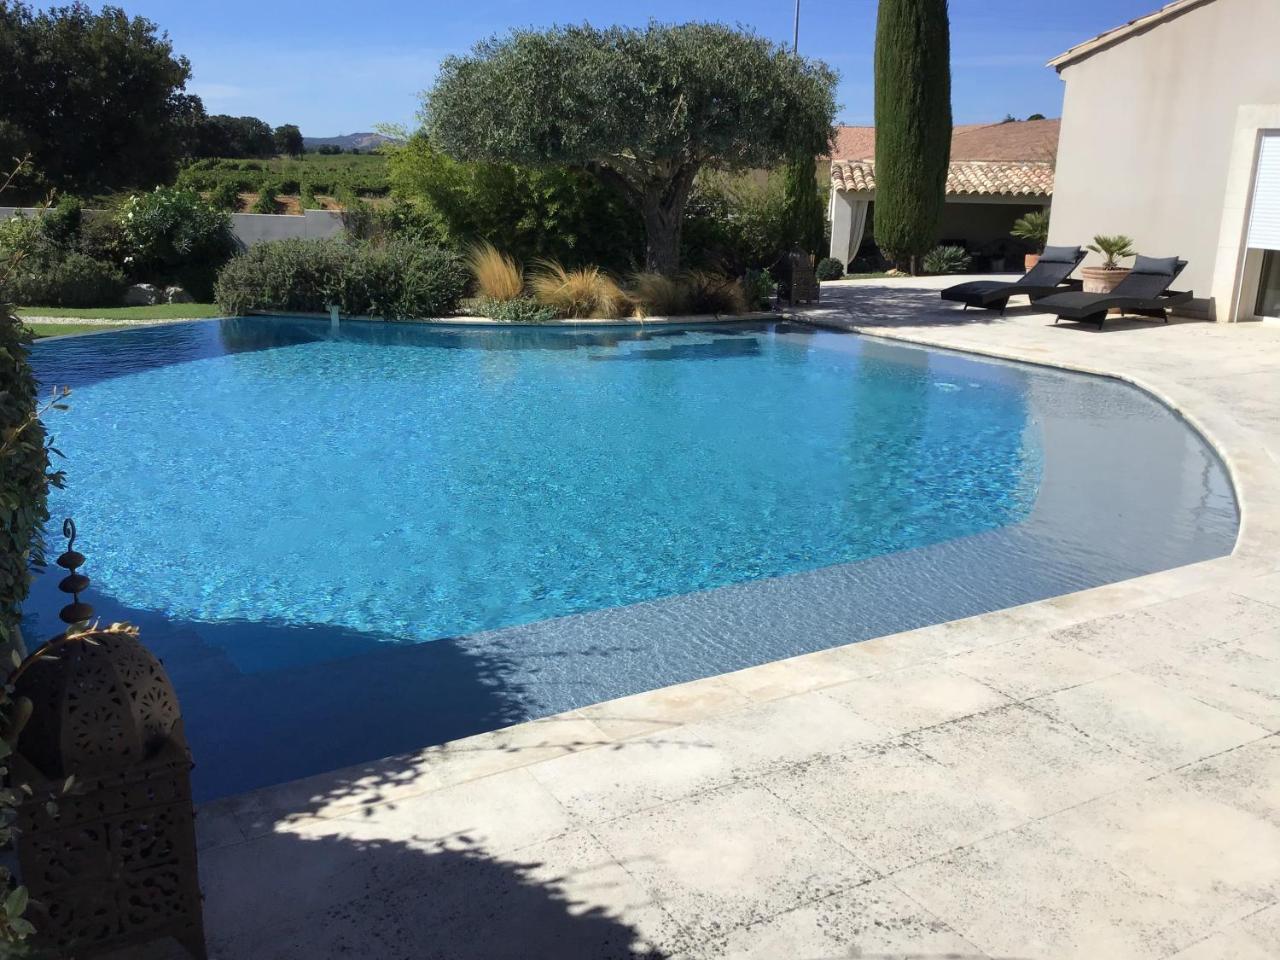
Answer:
[{"left": 13, "top": 521, "right": 205, "bottom": 960}]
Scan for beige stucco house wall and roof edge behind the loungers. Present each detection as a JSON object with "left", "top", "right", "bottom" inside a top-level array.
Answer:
[{"left": 1050, "top": 0, "right": 1280, "bottom": 321}]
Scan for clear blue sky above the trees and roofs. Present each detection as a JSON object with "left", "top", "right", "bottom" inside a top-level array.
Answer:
[{"left": 115, "top": 0, "right": 1164, "bottom": 136}]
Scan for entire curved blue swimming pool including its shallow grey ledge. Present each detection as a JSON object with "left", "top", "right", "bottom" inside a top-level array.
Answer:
[{"left": 28, "top": 317, "right": 1238, "bottom": 797}]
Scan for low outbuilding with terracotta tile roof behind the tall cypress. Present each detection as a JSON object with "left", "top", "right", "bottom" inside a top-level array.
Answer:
[{"left": 828, "top": 122, "right": 1054, "bottom": 269}]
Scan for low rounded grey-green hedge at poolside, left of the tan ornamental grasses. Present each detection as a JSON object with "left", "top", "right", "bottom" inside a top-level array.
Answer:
[{"left": 214, "top": 239, "right": 470, "bottom": 320}]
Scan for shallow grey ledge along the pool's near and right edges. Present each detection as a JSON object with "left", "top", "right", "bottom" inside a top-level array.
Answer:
[{"left": 28, "top": 321, "right": 1238, "bottom": 800}]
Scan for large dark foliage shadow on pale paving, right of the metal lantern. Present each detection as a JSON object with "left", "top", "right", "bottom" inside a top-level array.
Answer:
[{"left": 120, "top": 822, "right": 682, "bottom": 960}]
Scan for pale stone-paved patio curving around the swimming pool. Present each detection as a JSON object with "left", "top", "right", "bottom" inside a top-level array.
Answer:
[{"left": 152, "top": 280, "right": 1280, "bottom": 960}]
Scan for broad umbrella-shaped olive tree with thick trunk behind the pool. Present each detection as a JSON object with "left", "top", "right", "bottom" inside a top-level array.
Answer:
[{"left": 422, "top": 23, "right": 836, "bottom": 274}]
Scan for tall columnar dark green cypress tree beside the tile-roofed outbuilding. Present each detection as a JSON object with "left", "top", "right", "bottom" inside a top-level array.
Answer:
[{"left": 876, "top": 0, "right": 951, "bottom": 273}]
